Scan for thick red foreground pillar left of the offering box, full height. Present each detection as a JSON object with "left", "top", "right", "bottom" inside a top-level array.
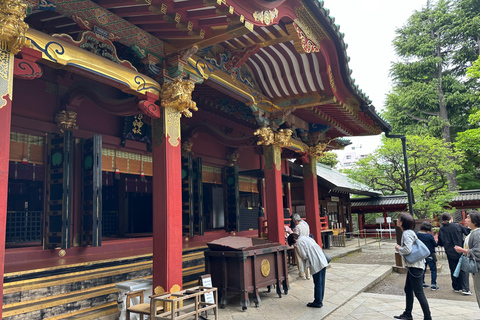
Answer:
[{"left": 152, "top": 107, "right": 182, "bottom": 293}]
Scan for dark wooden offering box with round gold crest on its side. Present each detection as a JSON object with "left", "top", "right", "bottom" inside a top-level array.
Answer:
[{"left": 205, "top": 237, "right": 288, "bottom": 310}]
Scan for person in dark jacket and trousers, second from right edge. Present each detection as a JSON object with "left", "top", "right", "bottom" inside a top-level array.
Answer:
[{"left": 438, "top": 212, "right": 472, "bottom": 295}]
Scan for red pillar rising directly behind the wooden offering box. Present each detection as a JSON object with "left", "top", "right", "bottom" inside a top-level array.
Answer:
[{"left": 263, "top": 145, "right": 285, "bottom": 244}]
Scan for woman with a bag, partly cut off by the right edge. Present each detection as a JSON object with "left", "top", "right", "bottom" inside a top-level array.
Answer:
[{"left": 455, "top": 210, "right": 480, "bottom": 307}]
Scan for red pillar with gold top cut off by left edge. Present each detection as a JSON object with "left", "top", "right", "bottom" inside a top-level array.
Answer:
[{"left": 0, "top": 41, "right": 14, "bottom": 319}]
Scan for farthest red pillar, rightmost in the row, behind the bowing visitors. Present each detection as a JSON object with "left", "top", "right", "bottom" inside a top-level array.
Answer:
[{"left": 303, "top": 155, "right": 322, "bottom": 246}]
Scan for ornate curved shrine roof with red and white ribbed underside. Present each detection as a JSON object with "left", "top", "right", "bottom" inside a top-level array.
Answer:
[{"left": 27, "top": 0, "right": 390, "bottom": 142}]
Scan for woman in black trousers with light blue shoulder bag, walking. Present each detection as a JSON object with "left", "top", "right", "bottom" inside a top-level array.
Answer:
[{"left": 394, "top": 212, "right": 432, "bottom": 320}]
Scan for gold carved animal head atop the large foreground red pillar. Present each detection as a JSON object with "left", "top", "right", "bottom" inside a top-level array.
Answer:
[{"left": 160, "top": 79, "right": 198, "bottom": 118}]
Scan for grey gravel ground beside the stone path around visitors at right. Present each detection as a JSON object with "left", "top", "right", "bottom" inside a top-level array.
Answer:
[{"left": 327, "top": 240, "right": 476, "bottom": 301}]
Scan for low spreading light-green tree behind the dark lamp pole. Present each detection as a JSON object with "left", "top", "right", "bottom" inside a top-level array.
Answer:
[{"left": 344, "top": 136, "right": 464, "bottom": 218}]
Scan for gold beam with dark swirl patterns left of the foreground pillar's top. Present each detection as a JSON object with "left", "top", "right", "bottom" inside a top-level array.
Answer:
[{"left": 26, "top": 29, "right": 160, "bottom": 96}]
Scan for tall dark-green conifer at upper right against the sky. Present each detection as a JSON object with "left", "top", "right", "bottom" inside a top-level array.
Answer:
[{"left": 384, "top": 0, "right": 478, "bottom": 190}]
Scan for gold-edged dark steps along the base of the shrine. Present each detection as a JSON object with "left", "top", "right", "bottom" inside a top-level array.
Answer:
[{"left": 3, "top": 247, "right": 206, "bottom": 320}]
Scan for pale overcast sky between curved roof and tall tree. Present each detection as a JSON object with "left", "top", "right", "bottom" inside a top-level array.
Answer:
[{"left": 324, "top": 0, "right": 427, "bottom": 151}]
